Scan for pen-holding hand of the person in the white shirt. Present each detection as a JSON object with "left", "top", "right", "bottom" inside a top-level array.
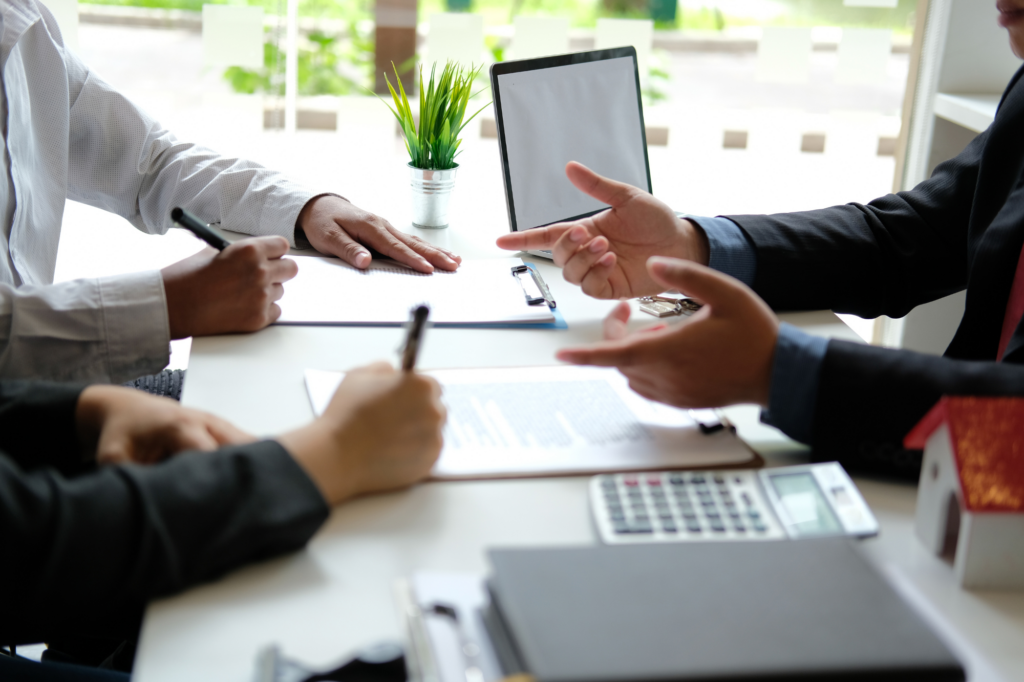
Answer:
[{"left": 160, "top": 237, "right": 298, "bottom": 339}]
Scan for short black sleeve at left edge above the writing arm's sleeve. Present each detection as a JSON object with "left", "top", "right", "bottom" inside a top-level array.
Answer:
[{"left": 0, "top": 381, "right": 93, "bottom": 474}]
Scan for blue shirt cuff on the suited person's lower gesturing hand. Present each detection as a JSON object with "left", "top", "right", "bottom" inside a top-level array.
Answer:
[{"left": 761, "top": 323, "right": 828, "bottom": 443}]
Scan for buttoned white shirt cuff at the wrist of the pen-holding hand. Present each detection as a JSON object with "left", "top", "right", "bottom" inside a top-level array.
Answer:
[{"left": 99, "top": 270, "right": 171, "bottom": 384}]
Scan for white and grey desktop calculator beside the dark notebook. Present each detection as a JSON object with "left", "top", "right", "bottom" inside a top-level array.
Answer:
[{"left": 590, "top": 462, "right": 879, "bottom": 545}]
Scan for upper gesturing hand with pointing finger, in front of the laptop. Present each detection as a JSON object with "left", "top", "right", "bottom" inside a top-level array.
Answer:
[{"left": 498, "top": 161, "right": 708, "bottom": 298}]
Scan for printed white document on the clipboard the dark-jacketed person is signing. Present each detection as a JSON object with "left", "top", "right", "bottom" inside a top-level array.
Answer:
[{"left": 306, "top": 366, "right": 755, "bottom": 478}]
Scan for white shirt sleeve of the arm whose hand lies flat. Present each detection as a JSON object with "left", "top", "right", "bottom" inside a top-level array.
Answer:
[{"left": 66, "top": 52, "right": 316, "bottom": 246}]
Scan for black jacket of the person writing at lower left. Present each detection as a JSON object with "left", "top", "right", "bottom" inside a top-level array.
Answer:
[{"left": 0, "top": 382, "right": 329, "bottom": 644}]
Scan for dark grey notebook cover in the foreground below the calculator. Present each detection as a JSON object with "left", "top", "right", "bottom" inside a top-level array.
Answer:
[{"left": 487, "top": 539, "right": 965, "bottom": 682}]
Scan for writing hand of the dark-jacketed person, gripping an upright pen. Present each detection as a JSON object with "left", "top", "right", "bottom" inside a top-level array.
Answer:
[{"left": 279, "top": 363, "right": 446, "bottom": 504}]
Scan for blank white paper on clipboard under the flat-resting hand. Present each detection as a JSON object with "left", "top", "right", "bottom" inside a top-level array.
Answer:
[{"left": 278, "top": 256, "right": 555, "bottom": 325}]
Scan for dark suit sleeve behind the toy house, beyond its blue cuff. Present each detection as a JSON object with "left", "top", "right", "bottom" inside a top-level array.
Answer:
[{"left": 811, "top": 340, "right": 1024, "bottom": 479}]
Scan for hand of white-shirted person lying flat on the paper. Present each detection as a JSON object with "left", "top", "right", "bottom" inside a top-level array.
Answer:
[{"left": 299, "top": 195, "right": 462, "bottom": 272}]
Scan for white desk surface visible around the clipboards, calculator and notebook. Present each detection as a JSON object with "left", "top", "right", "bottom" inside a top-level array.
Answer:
[{"left": 134, "top": 188, "right": 1024, "bottom": 682}]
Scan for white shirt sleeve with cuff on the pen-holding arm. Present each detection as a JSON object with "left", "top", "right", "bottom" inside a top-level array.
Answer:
[{"left": 0, "top": 270, "right": 170, "bottom": 383}]
